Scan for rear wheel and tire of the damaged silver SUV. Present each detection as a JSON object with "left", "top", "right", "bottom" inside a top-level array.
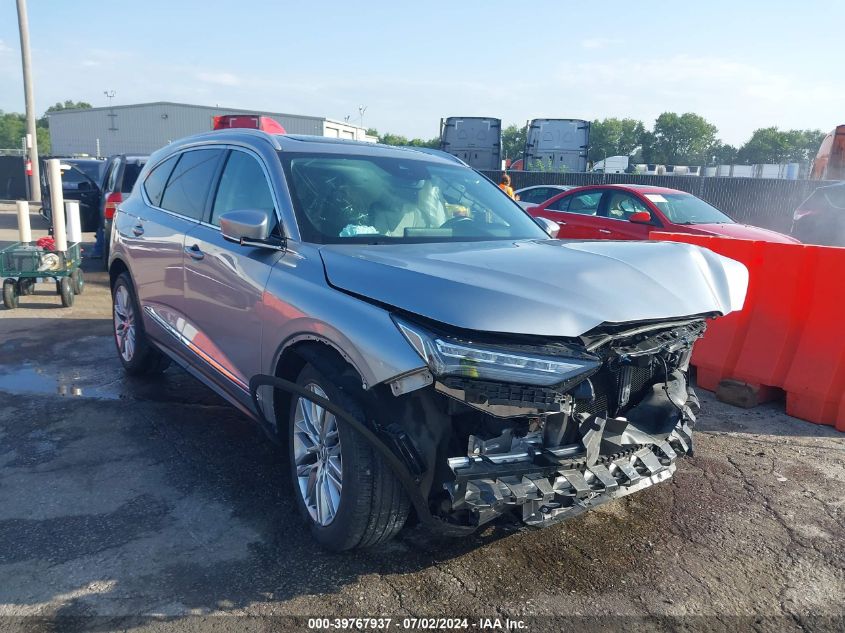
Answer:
[{"left": 112, "top": 272, "right": 170, "bottom": 376}]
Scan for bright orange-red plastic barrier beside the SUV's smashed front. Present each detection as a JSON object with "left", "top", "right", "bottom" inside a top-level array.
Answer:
[{"left": 651, "top": 232, "right": 845, "bottom": 431}]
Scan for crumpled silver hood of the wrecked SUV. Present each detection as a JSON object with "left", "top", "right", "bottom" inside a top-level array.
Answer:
[{"left": 320, "top": 240, "right": 748, "bottom": 336}]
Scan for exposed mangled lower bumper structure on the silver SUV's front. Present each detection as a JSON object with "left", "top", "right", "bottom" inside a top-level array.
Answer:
[{"left": 446, "top": 386, "right": 695, "bottom": 527}]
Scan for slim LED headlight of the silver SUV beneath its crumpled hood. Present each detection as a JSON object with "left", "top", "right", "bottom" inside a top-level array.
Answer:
[{"left": 393, "top": 316, "right": 601, "bottom": 387}]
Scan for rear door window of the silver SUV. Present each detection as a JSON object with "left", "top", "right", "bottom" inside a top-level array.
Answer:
[{"left": 161, "top": 149, "right": 222, "bottom": 220}]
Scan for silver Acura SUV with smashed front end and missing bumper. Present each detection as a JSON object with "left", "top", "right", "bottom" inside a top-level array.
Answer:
[{"left": 109, "top": 130, "right": 748, "bottom": 550}]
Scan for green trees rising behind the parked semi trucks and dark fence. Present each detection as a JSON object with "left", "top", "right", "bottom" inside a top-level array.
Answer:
[{"left": 367, "top": 112, "right": 825, "bottom": 165}]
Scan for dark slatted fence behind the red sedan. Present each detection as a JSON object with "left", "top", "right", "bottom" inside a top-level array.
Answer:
[{"left": 484, "top": 171, "right": 832, "bottom": 233}]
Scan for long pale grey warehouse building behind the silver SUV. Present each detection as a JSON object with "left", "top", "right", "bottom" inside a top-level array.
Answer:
[{"left": 48, "top": 101, "right": 377, "bottom": 156}]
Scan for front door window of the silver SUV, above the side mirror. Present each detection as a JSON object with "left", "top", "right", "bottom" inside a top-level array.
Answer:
[{"left": 211, "top": 150, "right": 275, "bottom": 226}]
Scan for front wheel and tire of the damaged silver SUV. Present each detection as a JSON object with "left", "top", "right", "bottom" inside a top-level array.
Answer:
[{"left": 288, "top": 365, "right": 410, "bottom": 551}]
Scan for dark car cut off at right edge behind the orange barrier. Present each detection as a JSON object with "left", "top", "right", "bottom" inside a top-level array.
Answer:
[{"left": 790, "top": 182, "right": 845, "bottom": 246}]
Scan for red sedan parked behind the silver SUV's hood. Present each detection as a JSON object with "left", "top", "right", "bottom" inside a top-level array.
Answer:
[{"left": 528, "top": 185, "right": 800, "bottom": 244}]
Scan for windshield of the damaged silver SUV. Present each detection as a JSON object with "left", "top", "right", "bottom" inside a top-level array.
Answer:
[{"left": 280, "top": 153, "right": 548, "bottom": 244}]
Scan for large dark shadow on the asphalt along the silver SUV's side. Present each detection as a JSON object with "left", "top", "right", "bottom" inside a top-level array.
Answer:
[{"left": 0, "top": 328, "right": 528, "bottom": 630}]
